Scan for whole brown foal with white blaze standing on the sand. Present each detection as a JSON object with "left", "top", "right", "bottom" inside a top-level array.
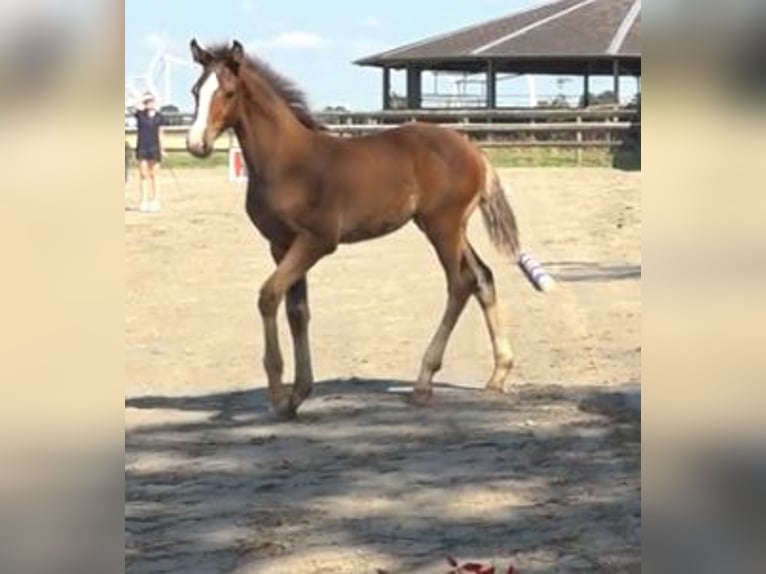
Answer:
[{"left": 186, "top": 39, "right": 532, "bottom": 418}]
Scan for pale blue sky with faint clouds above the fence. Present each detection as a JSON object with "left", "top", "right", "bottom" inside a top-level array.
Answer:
[{"left": 125, "top": 0, "right": 635, "bottom": 110}]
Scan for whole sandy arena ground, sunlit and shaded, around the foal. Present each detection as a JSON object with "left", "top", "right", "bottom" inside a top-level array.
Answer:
[{"left": 125, "top": 164, "right": 641, "bottom": 574}]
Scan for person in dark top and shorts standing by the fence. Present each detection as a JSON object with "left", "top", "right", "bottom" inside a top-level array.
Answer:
[{"left": 134, "top": 92, "right": 165, "bottom": 213}]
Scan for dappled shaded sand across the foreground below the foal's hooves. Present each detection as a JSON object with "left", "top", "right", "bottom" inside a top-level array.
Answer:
[{"left": 125, "top": 379, "right": 640, "bottom": 574}]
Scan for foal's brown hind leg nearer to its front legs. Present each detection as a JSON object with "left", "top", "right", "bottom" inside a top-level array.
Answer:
[{"left": 412, "top": 224, "right": 475, "bottom": 404}]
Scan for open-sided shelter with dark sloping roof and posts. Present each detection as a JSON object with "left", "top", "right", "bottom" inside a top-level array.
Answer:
[{"left": 354, "top": 0, "right": 641, "bottom": 109}]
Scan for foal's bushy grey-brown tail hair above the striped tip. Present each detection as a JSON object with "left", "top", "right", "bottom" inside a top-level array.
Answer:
[{"left": 479, "top": 154, "right": 520, "bottom": 261}]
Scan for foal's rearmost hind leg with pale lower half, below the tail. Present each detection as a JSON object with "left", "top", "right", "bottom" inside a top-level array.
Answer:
[{"left": 465, "top": 242, "right": 513, "bottom": 392}]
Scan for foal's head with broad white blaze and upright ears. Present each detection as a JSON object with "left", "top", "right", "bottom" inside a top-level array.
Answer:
[{"left": 186, "top": 40, "right": 245, "bottom": 157}]
